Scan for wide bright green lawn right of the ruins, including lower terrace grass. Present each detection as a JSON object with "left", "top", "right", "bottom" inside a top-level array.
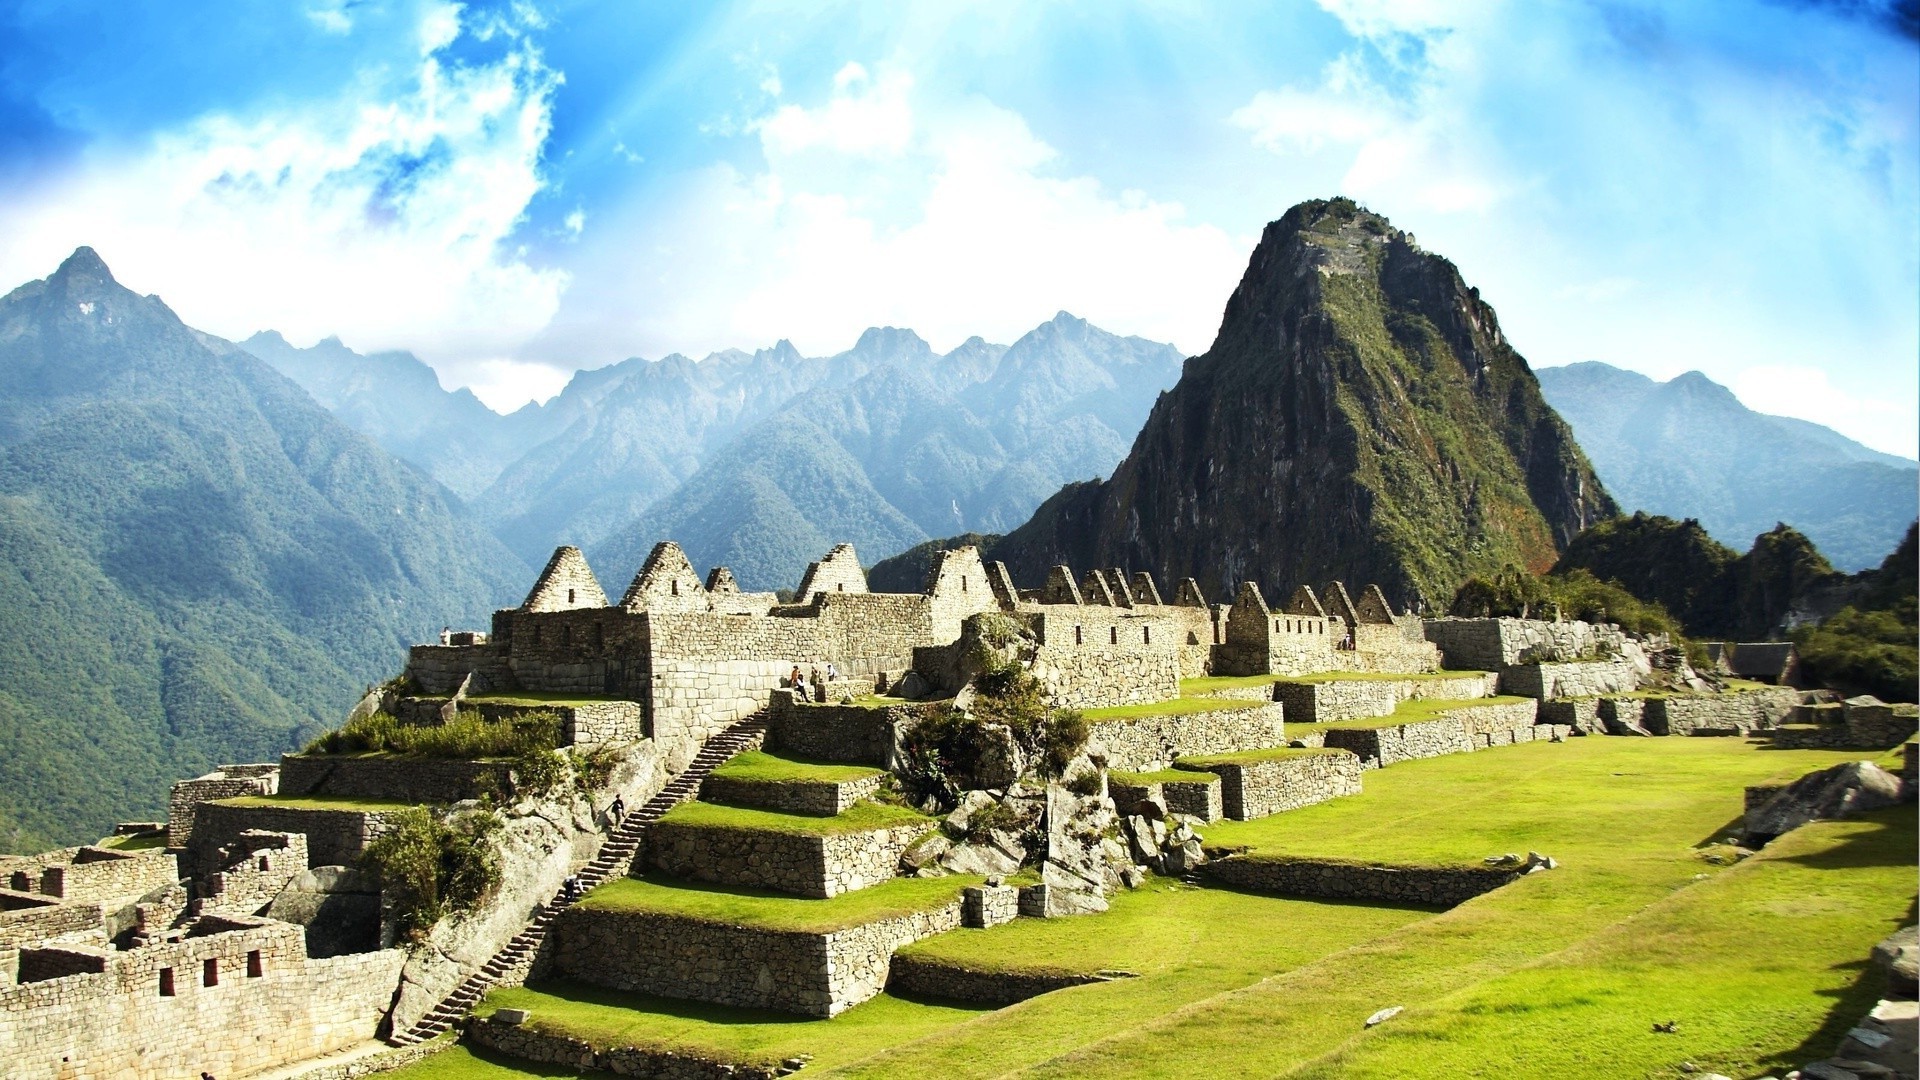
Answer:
[{"left": 385, "top": 736, "right": 1916, "bottom": 1080}]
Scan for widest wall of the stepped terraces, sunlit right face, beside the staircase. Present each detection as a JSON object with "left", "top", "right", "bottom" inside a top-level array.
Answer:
[{"left": 553, "top": 897, "right": 960, "bottom": 1017}]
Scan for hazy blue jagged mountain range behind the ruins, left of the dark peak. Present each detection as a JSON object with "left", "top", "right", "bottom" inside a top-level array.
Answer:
[{"left": 526, "top": 311, "right": 1181, "bottom": 590}]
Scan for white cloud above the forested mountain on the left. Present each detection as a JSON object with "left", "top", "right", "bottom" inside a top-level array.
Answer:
[{"left": 0, "top": 4, "right": 566, "bottom": 395}]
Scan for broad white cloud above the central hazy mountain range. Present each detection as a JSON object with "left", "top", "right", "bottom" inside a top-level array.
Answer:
[{"left": 538, "top": 65, "right": 1252, "bottom": 363}]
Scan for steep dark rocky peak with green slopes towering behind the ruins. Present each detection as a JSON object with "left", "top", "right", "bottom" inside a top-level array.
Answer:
[{"left": 995, "top": 200, "right": 1615, "bottom": 603}]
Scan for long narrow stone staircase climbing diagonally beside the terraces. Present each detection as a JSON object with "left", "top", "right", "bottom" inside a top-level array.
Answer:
[{"left": 386, "top": 713, "right": 766, "bottom": 1045}]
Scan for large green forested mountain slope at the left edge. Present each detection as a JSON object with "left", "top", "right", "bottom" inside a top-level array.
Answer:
[{"left": 0, "top": 248, "right": 530, "bottom": 849}]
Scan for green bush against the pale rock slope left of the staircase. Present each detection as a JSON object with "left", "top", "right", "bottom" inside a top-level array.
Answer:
[{"left": 363, "top": 807, "right": 503, "bottom": 942}]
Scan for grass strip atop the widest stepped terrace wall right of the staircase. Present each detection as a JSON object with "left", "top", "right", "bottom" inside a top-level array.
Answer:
[{"left": 578, "top": 874, "right": 981, "bottom": 934}]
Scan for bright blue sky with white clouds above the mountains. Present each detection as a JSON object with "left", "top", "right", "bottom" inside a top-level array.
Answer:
[{"left": 0, "top": 0, "right": 1920, "bottom": 457}]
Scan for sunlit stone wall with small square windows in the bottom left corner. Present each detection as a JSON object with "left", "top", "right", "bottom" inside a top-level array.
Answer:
[{"left": 0, "top": 920, "right": 405, "bottom": 1080}]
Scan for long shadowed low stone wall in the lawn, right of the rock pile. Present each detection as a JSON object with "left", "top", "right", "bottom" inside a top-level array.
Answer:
[{"left": 1200, "top": 855, "right": 1523, "bottom": 907}]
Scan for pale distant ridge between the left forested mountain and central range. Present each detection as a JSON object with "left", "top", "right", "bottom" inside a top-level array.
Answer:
[{"left": 240, "top": 331, "right": 553, "bottom": 498}]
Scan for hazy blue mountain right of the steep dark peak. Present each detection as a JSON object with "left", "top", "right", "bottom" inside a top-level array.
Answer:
[{"left": 1540, "top": 363, "right": 1920, "bottom": 571}]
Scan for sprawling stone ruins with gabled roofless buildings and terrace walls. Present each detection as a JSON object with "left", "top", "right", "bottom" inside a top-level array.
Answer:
[{"left": 0, "top": 542, "right": 1914, "bottom": 1080}]
